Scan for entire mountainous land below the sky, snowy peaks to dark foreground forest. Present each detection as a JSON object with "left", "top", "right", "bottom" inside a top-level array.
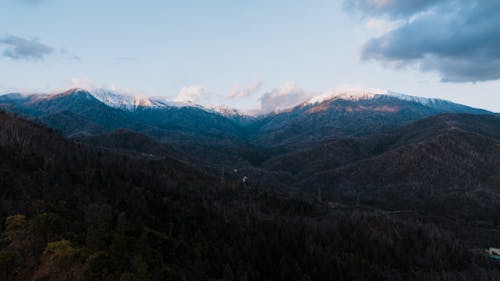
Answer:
[{"left": 0, "top": 89, "right": 500, "bottom": 280}]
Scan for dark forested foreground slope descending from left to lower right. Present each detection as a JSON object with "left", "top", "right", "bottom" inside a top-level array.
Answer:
[{"left": 0, "top": 110, "right": 500, "bottom": 281}]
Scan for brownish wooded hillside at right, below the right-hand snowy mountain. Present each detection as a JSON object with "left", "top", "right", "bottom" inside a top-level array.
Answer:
[{"left": 264, "top": 114, "right": 500, "bottom": 226}]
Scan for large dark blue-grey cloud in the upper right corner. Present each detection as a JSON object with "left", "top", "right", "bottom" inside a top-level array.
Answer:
[{"left": 345, "top": 0, "right": 500, "bottom": 82}]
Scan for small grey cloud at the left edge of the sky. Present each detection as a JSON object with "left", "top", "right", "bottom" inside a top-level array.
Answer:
[{"left": 0, "top": 36, "right": 54, "bottom": 60}]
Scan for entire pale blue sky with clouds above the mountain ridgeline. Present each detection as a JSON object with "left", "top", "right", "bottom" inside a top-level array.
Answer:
[{"left": 0, "top": 0, "right": 500, "bottom": 112}]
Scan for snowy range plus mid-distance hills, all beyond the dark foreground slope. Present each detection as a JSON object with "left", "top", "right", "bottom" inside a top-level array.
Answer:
[{"left": 0, "top": 89, "right": 500, "bottom": 217}]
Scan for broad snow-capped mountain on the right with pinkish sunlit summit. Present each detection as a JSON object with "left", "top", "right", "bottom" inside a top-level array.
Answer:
[{"left": 254, "top": 90, "right": 490, "bottom": 145}]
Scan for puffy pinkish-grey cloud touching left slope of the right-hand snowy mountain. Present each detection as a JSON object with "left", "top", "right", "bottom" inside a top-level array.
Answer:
[{"left": 260, "top": 82, "right": 315, "bottom": 113}]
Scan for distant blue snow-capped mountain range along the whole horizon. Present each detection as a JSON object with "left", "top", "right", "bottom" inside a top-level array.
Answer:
[{"left": 0, "top": 89, "right": 489, "bottom": 142}]
